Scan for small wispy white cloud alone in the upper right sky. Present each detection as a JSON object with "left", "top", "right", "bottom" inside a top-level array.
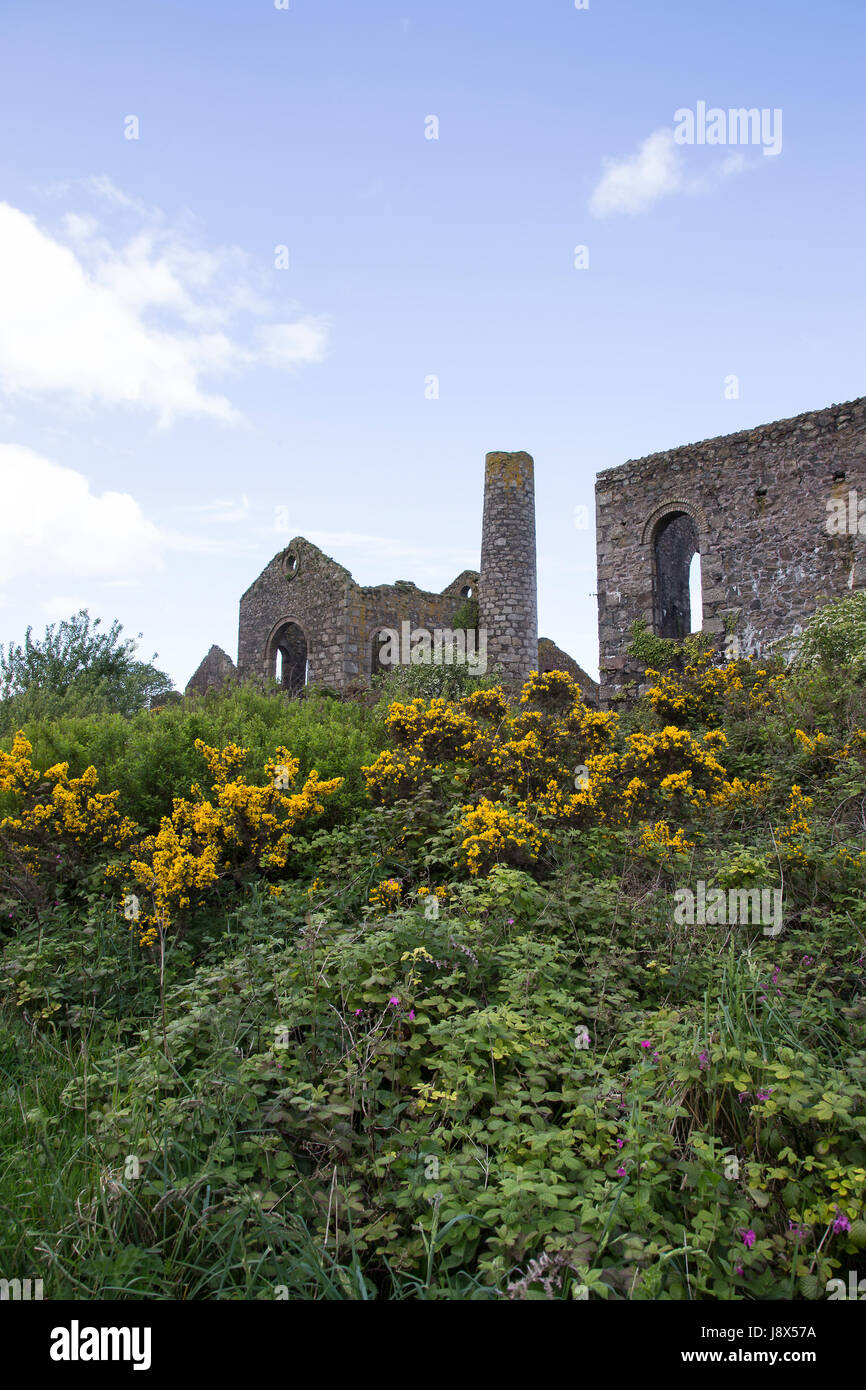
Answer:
[{"left": 589, "top": 128, "right": 748, "bottom": 217}]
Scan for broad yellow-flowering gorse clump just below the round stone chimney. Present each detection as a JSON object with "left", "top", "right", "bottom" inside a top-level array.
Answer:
[{"left": 363, "top": 667, "right": 767, "bottom": 876}]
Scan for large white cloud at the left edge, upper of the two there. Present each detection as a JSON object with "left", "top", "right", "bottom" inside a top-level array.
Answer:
[{"left": 0, "top": 179, "right": 328, "bottom": 425}]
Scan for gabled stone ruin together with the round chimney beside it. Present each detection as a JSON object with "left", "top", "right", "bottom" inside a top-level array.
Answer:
[{"left": 186, "top": 453, "right": 598, "bottom": 703}]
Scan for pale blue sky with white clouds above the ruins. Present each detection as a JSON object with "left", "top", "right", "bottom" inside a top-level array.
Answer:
[{"left": 0, "top": 0, "right": 866, "bottom": 685}]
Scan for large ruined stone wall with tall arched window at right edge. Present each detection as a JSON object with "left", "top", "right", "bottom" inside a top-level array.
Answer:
[{"left": 594, "top": 398, "right": 866, "bottom": 708}]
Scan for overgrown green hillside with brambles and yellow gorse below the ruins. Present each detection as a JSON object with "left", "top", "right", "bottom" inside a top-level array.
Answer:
[{"left": 0, "top": 625, "right": 866, "bottom": 1300}]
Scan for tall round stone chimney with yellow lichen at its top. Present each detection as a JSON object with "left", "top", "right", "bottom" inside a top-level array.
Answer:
[{"left": 478, "top": 453, "right": 538, "bottom": 684}]
